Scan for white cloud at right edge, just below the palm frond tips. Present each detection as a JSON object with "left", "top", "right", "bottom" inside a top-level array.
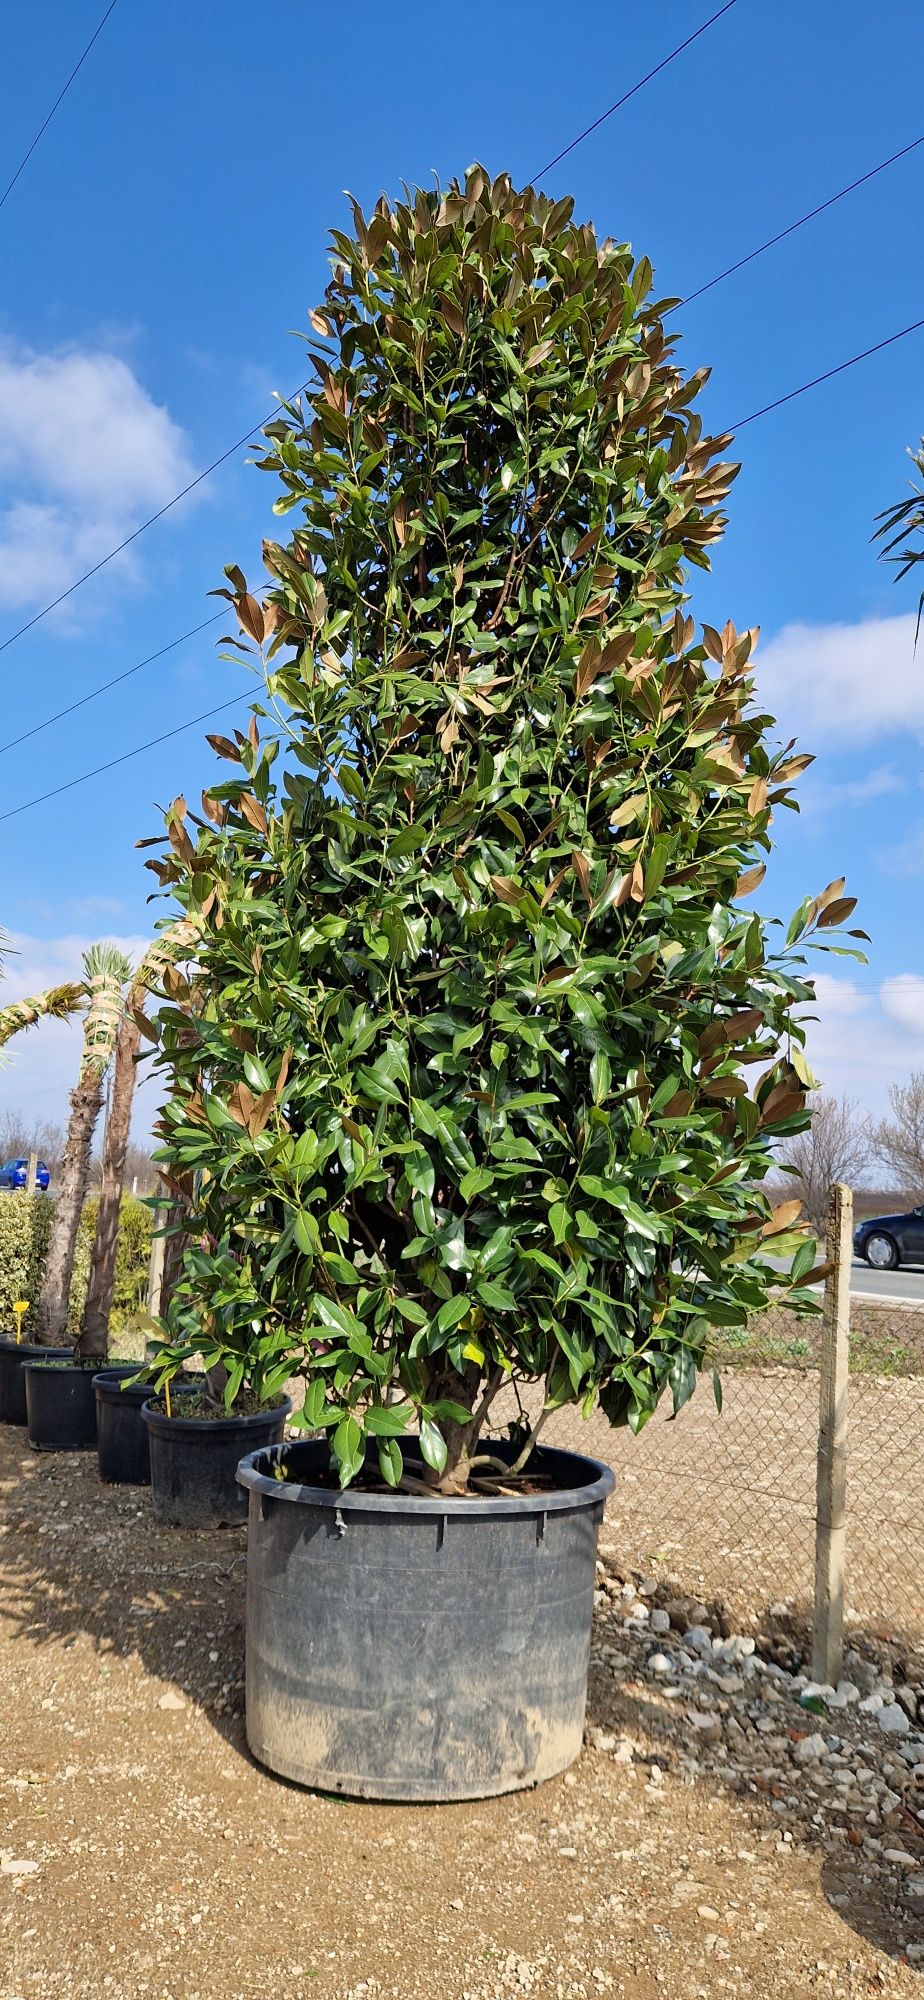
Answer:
[{"left": 756, "top": 612, "right": 924, "bottom": 752}]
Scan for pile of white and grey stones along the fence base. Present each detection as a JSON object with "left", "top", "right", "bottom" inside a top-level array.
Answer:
[{"left": 588, "top": 1546, "right": 924, "bottom": 1966}]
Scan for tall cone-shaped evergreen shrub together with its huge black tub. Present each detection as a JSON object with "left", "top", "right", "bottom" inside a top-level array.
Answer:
[{"left": 150, "top": 168, "right": 864, "bottom": 1798}]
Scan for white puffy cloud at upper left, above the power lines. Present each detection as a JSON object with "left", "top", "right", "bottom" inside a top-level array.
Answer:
[{"left": 0, "top": 344, "right": 192, "bottom": 608}]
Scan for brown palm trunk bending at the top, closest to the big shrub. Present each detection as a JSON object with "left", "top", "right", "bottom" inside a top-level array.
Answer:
[{"left": 78, "top": 920, "right": 198, "bottom": 1354}]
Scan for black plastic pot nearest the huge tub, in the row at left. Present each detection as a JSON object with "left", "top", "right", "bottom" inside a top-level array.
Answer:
[{"left": 142, "top": 1398, "right": 292, "bottom": 1528}]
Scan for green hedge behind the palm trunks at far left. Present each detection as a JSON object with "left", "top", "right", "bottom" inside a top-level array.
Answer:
[{"left": 0, "top": 1192, "right": 152, "bottom": 1332}]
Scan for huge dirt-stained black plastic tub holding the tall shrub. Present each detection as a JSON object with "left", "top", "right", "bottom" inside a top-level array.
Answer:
[{"left": 238, "top": 1440, "right": 614, "bottom": 1802}]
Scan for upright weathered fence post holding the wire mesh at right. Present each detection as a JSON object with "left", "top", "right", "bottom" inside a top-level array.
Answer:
[{"left": 812, "top": 1182, "right": 854, "bottom": 1686}]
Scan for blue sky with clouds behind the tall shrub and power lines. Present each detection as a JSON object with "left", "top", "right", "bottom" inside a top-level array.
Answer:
[{"left": 0, "top": 0, "right": 924, "bottom": 1116}]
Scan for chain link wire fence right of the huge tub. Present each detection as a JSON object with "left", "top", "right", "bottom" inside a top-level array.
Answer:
[{"left": 502, "top": 1306, "right": 924, "bottom": 1640}]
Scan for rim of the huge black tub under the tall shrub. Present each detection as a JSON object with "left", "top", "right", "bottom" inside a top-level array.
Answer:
[{"left": 236, "top": 1444, "right": 616, "bottom": 1520}]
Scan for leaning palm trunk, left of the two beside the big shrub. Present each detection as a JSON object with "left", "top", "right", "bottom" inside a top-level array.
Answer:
[{"left": 34, "top": 944, "right": 132, "bottom": 1348}]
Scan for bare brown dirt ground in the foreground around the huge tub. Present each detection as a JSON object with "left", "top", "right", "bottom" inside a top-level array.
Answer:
[{"left": 0, "top": 1426, "right": 924, "bottom": 2000}]
